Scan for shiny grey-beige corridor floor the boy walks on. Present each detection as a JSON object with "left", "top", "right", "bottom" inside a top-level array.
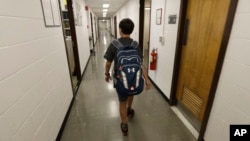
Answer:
[{"left": 61, "top": 30, "right": 196, "bottom": 141}]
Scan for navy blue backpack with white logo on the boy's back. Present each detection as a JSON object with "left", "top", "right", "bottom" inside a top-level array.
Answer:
[{"left": 112, "top": 40, "right": 144, "bottom": 95}]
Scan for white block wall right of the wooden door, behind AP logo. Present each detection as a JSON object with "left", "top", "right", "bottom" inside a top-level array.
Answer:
[{"left": 205, "top": 0, "right": 250, "bottom": 141}]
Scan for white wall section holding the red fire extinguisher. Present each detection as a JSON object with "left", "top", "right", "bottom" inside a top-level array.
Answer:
[{"left": 148, "top": 0, "right": 180, "bottom": 98}]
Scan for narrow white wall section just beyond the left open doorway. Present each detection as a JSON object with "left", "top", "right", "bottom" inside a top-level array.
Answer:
[{"left": 74, "top": 0, "right": 90, "bottom": 73}]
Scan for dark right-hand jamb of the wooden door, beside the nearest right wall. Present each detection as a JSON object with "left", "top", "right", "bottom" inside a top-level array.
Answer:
[{"left": 198, "top": 0, "right": 238, "bottom": 141}]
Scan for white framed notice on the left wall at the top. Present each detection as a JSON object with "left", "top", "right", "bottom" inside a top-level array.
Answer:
[{"left": 41, "top": 0, "right": 61, "bottom": 27}]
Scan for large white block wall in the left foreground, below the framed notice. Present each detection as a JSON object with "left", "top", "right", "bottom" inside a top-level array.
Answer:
[{"left": 0, "top": 0, "right": 73, "bottom": 141}]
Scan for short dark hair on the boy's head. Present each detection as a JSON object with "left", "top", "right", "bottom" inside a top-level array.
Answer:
[{"left": 119, "top": 18, "right": 134, "bottom": 34}]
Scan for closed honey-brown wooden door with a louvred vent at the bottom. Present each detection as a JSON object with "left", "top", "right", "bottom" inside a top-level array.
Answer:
[{"left": 176, "top": 0, "right": 230, "bottom": 121}]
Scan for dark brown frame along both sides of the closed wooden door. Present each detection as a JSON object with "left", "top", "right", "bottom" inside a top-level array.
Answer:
[{"left": 169, "top": 0, "right": 238, "bottom": 141}]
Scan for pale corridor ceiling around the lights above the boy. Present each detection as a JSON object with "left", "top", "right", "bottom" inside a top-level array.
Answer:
[{"left": 85, "top": 0, "right": 128, "bottom": 17}]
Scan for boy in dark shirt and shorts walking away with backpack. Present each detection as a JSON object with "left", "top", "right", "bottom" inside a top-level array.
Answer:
[{"left": 104, "top": 18, "right": 151, "bottom": 136}]
